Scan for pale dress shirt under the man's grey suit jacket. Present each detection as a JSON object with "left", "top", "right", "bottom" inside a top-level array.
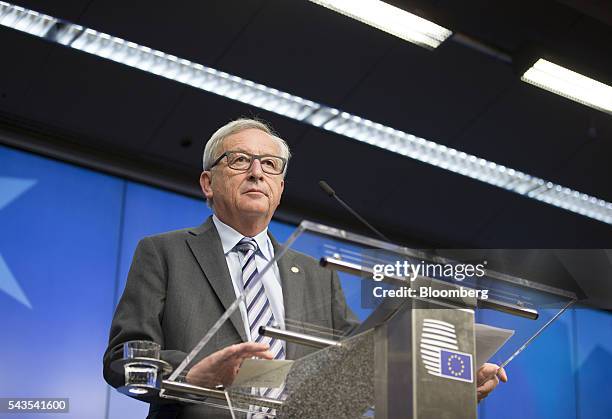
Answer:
[{"left": 213, "top": 215, "right": 285, "bottom": 340}]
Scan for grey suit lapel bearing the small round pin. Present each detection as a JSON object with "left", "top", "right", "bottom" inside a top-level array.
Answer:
[{"left": 270, "top": 235, "right": 305, "bottom": 359}]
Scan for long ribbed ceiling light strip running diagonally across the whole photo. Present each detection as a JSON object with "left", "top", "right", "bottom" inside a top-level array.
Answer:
[{"left": 0, "top": 1, "right": 612, "bottom": 224}]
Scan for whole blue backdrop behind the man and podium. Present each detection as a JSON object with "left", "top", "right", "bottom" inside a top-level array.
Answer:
[{"left": 0, "top": 146, "right": 612, "bottom": 419}]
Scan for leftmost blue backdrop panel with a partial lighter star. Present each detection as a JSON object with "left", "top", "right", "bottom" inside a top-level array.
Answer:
[{"left": 0, "top": 147, "right": 123, "bottom": 419}]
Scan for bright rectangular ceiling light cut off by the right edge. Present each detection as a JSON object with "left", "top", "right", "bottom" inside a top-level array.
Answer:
[{"left": 521, "top": 58, "right": 612, "bottom": 114}]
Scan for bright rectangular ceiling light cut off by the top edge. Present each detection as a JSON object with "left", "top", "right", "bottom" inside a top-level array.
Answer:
[{"left": 310, "top": 0, "right": 452, "bottom": 49}]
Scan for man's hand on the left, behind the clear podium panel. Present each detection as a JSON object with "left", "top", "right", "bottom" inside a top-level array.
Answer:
[{"left": 187, "top": 342, "right": 274, "bottom": 387}]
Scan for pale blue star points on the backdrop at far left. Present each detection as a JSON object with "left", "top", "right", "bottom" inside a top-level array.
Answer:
[{"left": 0, "top": 177, "right": 37, "bottom": 308}]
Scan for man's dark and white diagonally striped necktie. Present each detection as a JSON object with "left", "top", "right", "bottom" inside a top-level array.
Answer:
[{"left": 236, "top": 237, "right": 285, "bottom": 412}]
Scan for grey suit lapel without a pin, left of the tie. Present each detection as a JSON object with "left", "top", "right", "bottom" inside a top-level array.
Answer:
[{"left": 187, "top": 217, "right": 247, "bottom": 342}]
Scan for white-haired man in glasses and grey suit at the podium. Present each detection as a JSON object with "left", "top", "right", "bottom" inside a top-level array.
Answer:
[{"left": 104, "top": 119, "right": 356, "bottom": 419}]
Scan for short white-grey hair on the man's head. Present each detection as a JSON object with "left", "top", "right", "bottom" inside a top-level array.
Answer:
[{"left": 202, "top": 118, "right": 291, "bottom": 177}]
